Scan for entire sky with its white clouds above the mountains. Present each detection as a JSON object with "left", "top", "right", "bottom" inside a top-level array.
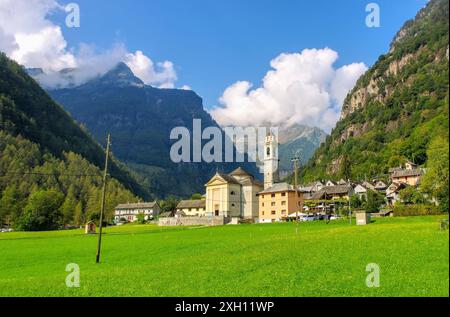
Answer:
[{"left": 0, "top": 0, "right": 427, "bottom": 132}]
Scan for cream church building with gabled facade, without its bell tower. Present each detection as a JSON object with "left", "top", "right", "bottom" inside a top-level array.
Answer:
[{"left": 205, "top": 167, "right": 263, "bottom": 219}]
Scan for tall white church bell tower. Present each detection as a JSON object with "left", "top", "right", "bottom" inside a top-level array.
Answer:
[{"left": 264, "top": 132, "right": 280, "bottom": 189}]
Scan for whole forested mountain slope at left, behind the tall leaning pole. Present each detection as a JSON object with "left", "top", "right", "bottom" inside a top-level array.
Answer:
[{"left": 0, "top": 54, "right": 145, "bottom": 230}]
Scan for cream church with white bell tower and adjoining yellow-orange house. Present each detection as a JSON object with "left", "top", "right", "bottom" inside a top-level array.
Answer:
[{"left": 179, "top": 133, "right": 302, "bottom": 222}]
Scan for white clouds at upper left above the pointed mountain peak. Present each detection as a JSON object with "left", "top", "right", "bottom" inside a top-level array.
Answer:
[{"left": 0, "top": 0, "right": 177, "bottom": 88}]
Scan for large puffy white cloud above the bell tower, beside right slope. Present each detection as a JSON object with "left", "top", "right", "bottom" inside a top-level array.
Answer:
[{"left": 211, "top": 48, "right": 367, "bottom": 131}]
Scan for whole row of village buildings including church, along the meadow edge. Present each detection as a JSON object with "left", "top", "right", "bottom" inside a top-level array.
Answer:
[{"left": 115, "top": 134, "right": 425, "bottom": 225}]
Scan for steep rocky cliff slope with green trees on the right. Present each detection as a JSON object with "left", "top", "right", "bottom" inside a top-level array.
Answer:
[{"left": 303, "top": 0, "right": 449, "bottom": 180}]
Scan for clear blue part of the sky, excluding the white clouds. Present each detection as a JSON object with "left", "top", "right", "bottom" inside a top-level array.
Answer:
[{"left": 53, "top": 0, "right": 427, "bottom": 108}]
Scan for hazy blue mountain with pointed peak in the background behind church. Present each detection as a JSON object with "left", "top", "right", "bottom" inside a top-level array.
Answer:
[{"left": 49, "top": 63, "right": 259, "bottom": 197}]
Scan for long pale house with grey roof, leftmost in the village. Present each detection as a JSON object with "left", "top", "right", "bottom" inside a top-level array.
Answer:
[{"left": 114, "top": 201, "right": 161, "bottom": 222}]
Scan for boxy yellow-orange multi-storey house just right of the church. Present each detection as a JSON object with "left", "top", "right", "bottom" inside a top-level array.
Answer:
[{"left": 258, "top": 183, "right": 303, "bottom": 222}]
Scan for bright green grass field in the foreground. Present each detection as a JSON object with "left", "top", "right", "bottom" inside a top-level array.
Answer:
[{"left": 0, "top": 216, "right": 449, "bottom": 297}]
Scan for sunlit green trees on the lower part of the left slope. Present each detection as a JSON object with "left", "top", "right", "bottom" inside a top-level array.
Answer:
[{"left": 0, "top": 131, "right": 139, "bottom": 231}]
